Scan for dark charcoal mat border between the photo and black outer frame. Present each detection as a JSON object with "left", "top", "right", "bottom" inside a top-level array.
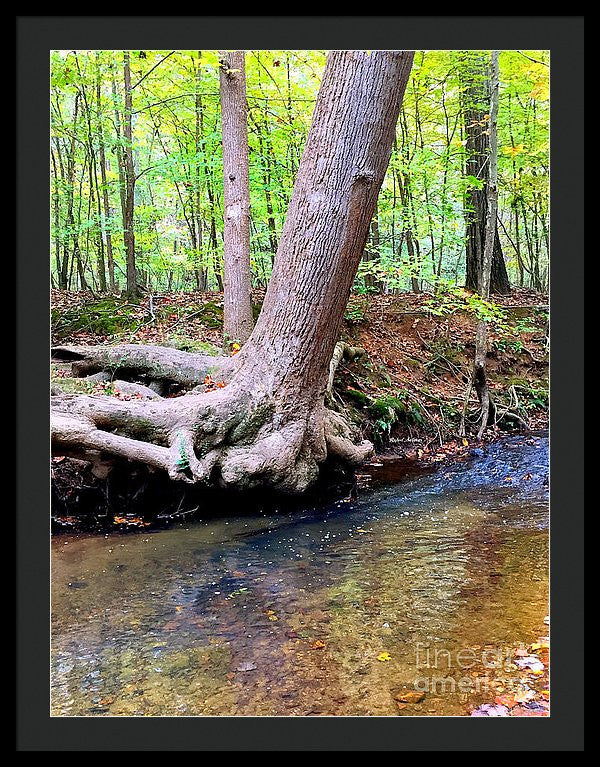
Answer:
[{"left": 15, "top": 16, "right": 585, "bottom": 751}]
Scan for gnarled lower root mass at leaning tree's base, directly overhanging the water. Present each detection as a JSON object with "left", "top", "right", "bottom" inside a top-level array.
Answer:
[{"left": 51, "top": 386, "right": 372, "bottom": 493}]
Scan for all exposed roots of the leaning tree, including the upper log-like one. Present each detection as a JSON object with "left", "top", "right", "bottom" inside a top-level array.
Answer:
[{"left": 51, "top": 345, "right": 372, "bottom": 493}]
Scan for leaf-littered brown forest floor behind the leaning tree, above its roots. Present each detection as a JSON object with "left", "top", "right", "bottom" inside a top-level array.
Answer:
[{"left": 52, "top": 289, "right": 548, "bottom": 460}]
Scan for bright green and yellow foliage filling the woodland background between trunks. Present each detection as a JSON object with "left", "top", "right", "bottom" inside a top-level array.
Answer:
[{"left": 50, "top": 50, "right": 549, "bottom": 294}]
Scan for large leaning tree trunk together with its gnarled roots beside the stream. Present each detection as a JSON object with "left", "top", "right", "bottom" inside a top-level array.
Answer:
[{"left": 52, "top": 51, "right": 413, "bottom": 493}]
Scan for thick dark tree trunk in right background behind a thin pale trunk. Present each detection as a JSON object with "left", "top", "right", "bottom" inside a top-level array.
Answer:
[{"left": 462, "top": 51, "right": 510, "bottom": 294}]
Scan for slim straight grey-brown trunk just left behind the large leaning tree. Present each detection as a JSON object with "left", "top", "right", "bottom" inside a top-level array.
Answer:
[{"left": 219, "top": 51, "right": 253, "bottom": 342}]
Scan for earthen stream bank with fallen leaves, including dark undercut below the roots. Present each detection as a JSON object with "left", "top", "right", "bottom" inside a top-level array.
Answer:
[{"left": 51, "top": 289, "right": 548, "bottom": 531}]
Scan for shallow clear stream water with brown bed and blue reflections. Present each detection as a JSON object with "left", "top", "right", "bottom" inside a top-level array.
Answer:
[{"left": 51, "top": 435, "right": 548, "bottom": 716}]
